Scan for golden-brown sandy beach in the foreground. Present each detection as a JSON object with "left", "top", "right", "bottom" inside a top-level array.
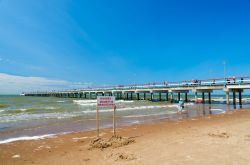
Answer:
[{"left": 0, "top": 109, "right": 250, "bottom": 165}]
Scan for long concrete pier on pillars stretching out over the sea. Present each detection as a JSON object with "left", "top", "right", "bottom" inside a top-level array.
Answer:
[{"left": 24, "top": 76, "right": 250, "bottom": 105}]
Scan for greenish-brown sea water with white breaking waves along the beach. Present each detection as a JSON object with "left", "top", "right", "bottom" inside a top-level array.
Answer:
[{"left": 0, "top": 96, "right": 250, "bottom": 143}]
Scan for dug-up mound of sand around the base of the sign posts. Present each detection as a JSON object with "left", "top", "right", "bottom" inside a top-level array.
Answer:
[{"left": 90, "top": 135, "right": 135, "bottom": 149}]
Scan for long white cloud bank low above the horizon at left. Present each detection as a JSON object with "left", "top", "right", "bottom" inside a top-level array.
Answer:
[{"left": 0, "top": 73, "right": 91, "bottom": 94}]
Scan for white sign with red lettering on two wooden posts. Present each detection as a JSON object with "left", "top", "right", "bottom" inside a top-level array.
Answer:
[{"left": 96, "top": 96, "right": 116, "bottom": 137}]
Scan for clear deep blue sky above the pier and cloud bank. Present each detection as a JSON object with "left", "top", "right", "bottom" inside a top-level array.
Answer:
[{"left": 0, "top": 0, "right": 250, "bottom": 92}]
